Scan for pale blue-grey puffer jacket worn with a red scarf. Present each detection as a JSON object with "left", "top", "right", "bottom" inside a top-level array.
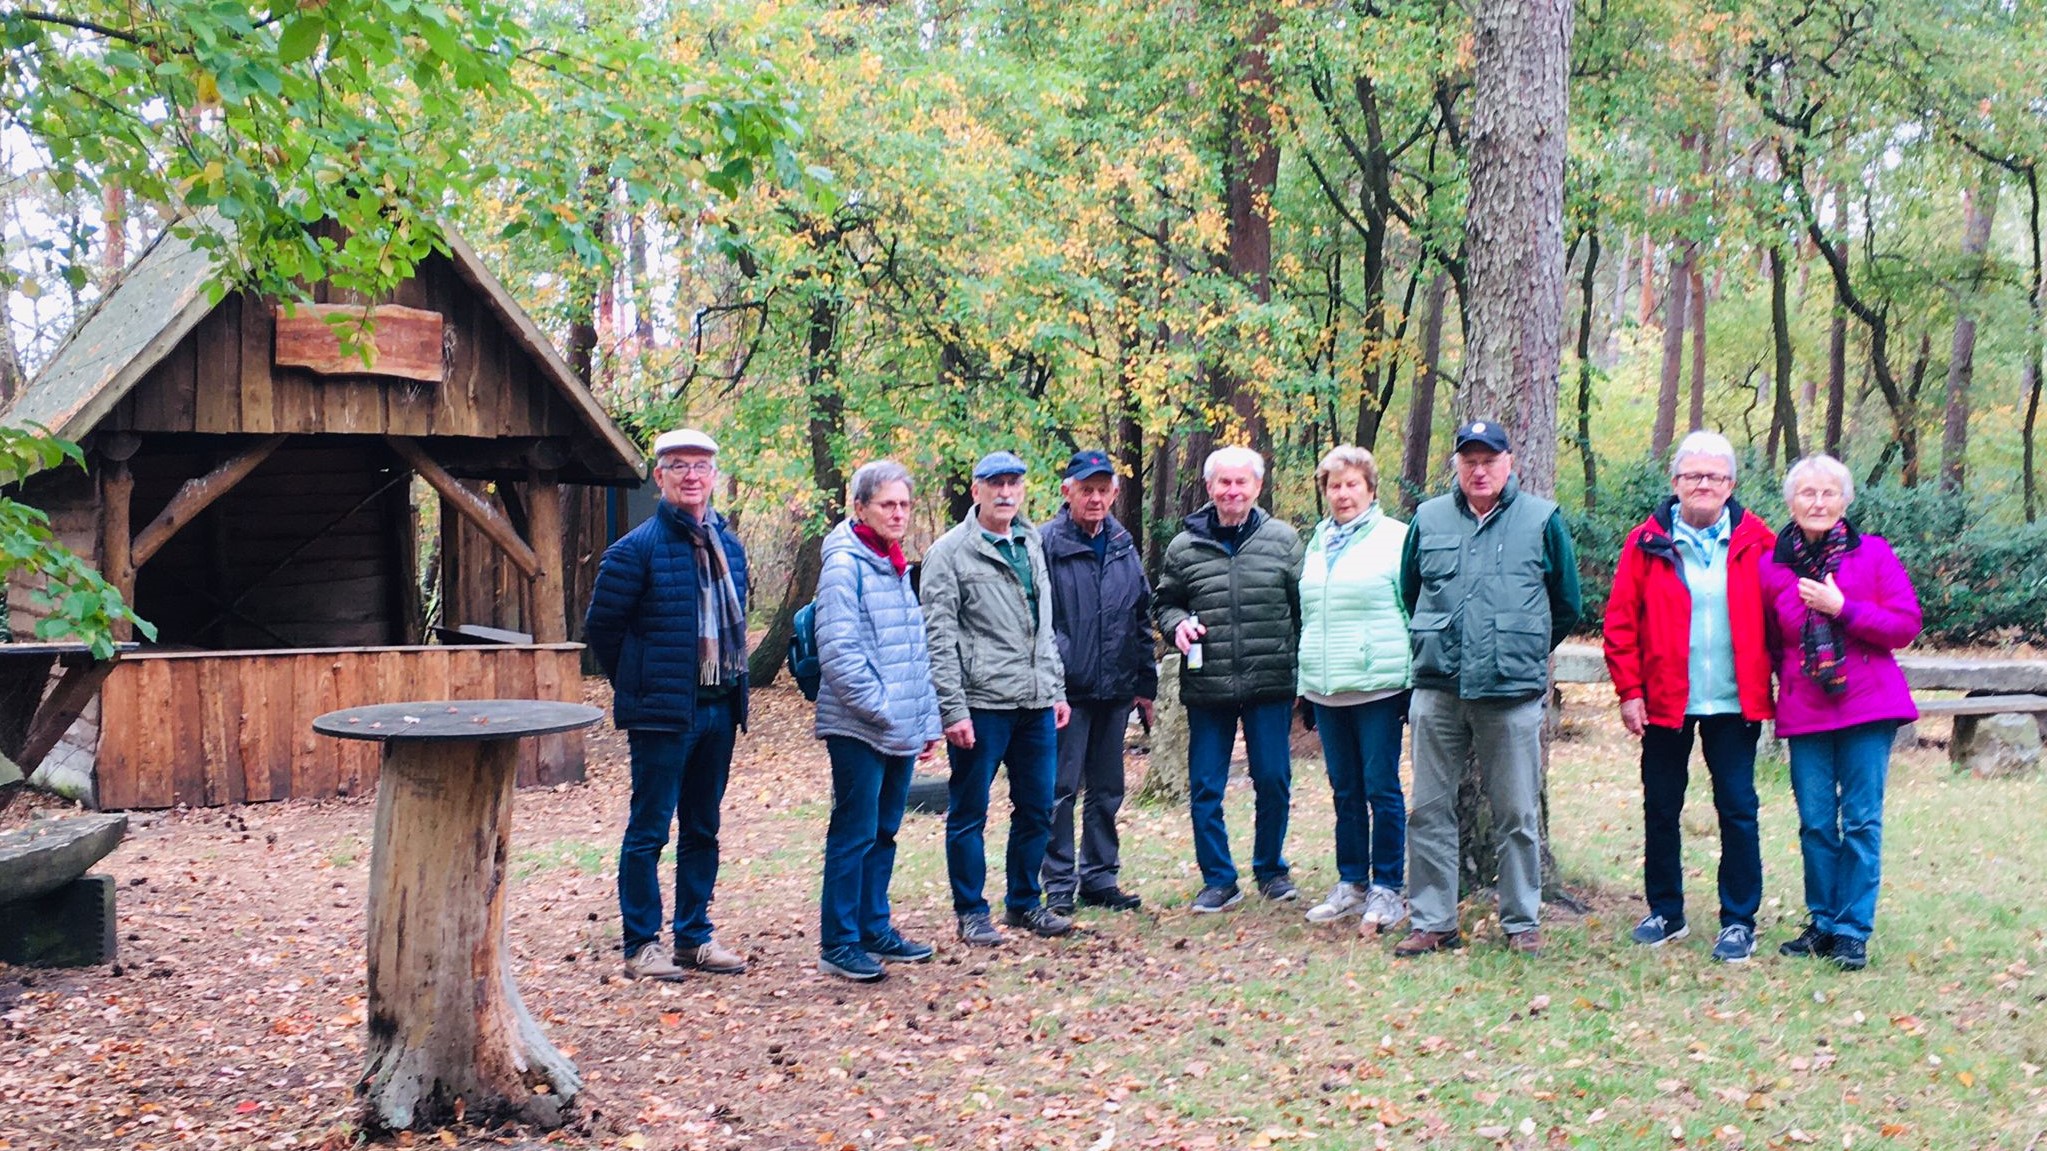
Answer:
[{"left": 817, "top": 520, "right": 944, "bottom": 756}]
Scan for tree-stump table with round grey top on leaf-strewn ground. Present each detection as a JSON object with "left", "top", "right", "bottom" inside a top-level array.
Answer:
[{"left": 313, "top": 700, "right": 604, "bottom": 1131}]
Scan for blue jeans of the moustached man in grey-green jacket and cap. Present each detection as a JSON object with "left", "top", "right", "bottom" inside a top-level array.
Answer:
[{"left": 946, "top": 707, "right": 1058, "bottom": 915}]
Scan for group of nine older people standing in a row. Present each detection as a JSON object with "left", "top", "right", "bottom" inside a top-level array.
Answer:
[{"left": 585, "top": 420, "right": 1918, "bottom": 983}]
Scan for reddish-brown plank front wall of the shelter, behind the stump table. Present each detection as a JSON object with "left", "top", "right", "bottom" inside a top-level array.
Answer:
[{"left": 96, "top": 643, "right": 583, "bottom": 811}]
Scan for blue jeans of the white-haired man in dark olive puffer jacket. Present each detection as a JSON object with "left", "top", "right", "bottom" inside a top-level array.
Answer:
[{"left": 1187, "top": 700, "right": 1294, "bottom": 887}]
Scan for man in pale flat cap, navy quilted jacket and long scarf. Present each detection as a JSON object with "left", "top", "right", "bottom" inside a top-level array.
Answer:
[{"left": 583, "top": 428, "right": 747, "bottom": 981}]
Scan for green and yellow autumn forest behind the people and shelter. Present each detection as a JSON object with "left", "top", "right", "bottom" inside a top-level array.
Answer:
[{"left": 0, "top": 0, "right": 2047, "bottom": 651}]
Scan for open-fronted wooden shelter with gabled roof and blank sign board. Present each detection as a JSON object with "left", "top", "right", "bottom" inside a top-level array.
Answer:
[{"left": 4, "top": 217, "right": 643, "bottom": 807}]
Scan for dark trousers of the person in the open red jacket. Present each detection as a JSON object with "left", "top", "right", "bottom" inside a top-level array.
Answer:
[{"left": 1642, "top": 715, "right": 1762, "bottom": 930}]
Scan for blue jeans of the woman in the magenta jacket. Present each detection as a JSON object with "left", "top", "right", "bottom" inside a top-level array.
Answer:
[{"left": 1789, "top": 719, "right": 1898, "bottom": 940}]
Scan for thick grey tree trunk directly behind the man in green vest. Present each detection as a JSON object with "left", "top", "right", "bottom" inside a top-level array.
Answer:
[{"left": 1457, "top": 0, "right": 1563, "bottom": 895}]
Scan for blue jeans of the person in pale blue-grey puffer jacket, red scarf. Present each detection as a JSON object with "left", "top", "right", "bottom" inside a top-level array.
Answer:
[{"left": 817, "top": 735, "right": 917, "bottom": 950}]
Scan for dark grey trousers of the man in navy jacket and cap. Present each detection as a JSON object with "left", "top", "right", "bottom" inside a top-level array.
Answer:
[{"left": 1038, "top": 700, "right": 1130, "bottom": 903}]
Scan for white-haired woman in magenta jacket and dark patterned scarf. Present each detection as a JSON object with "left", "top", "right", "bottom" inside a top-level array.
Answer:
[{"left": 1762, "top": 455, "right": 1920, "bottom": 971}]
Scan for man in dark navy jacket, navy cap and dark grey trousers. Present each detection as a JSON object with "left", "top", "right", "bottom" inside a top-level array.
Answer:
[{"left": 1038, "top": 451, "right": 1159, "bottom": 915}]
